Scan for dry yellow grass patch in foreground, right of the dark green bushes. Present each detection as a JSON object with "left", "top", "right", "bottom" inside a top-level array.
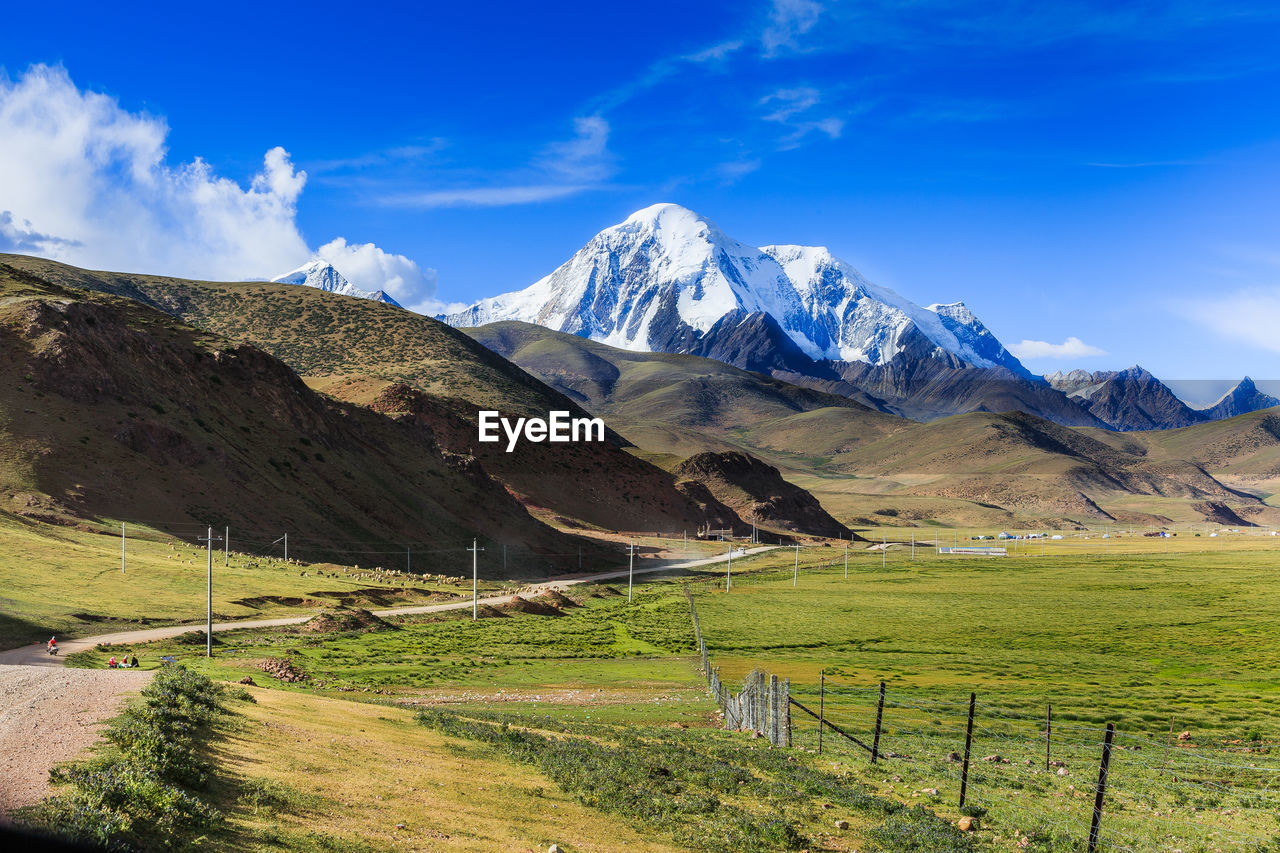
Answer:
[{"left": 215, "top": 689, "right": 680, "bottom": 852}]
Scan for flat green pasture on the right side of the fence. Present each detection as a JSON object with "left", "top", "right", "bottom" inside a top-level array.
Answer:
[{"left": 698, "top": 535, "right": 1280, "bottom": 853}]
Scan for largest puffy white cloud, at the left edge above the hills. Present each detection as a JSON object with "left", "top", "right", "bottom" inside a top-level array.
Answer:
[{"left": 0, "top": 65, "right": 308, "bottom": 279}]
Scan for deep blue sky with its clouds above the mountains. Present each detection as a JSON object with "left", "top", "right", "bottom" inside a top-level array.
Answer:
[{"left": 0, "top": 0, "right": 1280, "bottom": 379}]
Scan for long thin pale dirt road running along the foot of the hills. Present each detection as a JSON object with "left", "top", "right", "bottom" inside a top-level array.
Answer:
[{"left": 0, "top": 546, "right": 776, "bottom": 669}]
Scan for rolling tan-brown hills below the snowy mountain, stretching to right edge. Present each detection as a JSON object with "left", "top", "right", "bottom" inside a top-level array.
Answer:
[{"left": 470, "top": 323, "right": 1280, "bottom": 524}]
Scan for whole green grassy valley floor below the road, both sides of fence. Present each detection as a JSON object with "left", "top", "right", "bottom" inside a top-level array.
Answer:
[{"left": 42, "top": 529, "right": 1280, "bottom": 853}]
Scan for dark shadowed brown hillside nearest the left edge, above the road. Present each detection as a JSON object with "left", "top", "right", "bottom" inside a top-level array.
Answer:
[{"left": 0, "top": 258, "right": 580, "bottom": 566}]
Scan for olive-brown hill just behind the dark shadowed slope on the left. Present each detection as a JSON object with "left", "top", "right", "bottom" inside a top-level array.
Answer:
[{"left": 0, "top": 255, "right": 733, "bottom": 532}]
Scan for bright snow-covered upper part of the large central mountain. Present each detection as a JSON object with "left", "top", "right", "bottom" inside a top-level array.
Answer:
[{"left": 444, "top": 204, "right": 1029, "bottom": 377}]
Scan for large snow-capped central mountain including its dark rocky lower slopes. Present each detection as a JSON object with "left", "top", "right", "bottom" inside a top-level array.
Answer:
[{"left": 445, "top": 204, "right": 1102, "bottom": 425}]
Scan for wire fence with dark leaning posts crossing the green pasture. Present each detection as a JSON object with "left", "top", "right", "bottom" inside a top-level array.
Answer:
[{"left": 686, "top": 588, "right": 1280, "bottom": 853}]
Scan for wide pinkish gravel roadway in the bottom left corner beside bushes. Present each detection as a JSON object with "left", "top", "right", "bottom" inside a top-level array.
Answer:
[{"left": 0, "top": 665, "right": 151, "bottom": 820}]
